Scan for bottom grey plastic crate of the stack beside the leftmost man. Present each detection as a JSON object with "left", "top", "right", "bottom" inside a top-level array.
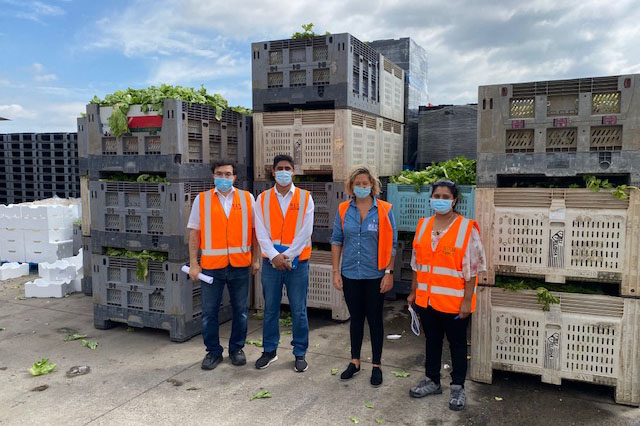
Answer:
[{"left": 92, "top": 255, "right": 232, "bottom": 342}]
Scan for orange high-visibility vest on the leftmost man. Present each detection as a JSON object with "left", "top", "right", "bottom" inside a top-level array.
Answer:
[{"left": 200, "top": 188, "right": 253, "bottom": 269}]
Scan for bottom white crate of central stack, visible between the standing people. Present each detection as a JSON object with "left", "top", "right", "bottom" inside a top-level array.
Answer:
[{"left": 254, "top": 252, "right": 349, "bottom": 321}]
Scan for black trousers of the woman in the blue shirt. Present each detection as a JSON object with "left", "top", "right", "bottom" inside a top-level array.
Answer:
[{"left": 342, "top": 275, "right": 384, "bottom": 364}]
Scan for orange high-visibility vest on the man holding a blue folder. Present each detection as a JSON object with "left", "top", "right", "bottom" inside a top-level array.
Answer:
[{"left": 260, "top": 187, "right": 311, "bottom": 260}]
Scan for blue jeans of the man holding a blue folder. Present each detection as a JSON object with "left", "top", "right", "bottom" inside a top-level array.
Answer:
[{"left": 261, "top": 259, "right": 309, "bottom": 355}]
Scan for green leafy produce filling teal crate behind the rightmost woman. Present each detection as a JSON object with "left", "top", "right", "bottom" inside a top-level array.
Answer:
[{"left": 390, "top": 157, "right": 476, "bottom": 192}]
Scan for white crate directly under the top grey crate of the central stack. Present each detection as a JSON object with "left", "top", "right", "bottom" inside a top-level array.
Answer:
[{"left": 253, "top": 109, "right": 404, "bottom": 182}]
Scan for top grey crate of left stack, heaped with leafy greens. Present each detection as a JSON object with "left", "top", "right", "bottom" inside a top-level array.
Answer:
[{"left": 83, "top": 99, "right": 252, "bottom": 172}]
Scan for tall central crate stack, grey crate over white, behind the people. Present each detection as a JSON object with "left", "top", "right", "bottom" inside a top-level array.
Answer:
[{"left": 251, "top": 33, "right": 404, "bottom": 320}]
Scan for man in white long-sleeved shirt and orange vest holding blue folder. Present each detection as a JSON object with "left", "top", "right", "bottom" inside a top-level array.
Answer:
[{"left": 255, "top": 155, "right": 314, "bottom": 372}]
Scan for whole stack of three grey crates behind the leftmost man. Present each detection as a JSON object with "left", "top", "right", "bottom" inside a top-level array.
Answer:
[{"left": 78, "top": 99, "right": 252, "bottom": 342}]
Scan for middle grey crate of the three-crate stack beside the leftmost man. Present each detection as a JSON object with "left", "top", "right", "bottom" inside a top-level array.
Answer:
[{"left": 89, "top": 180, "right": 213, "bottom": 236}]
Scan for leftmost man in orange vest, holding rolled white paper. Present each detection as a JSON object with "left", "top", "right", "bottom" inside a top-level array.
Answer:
[{"left": 187, "top": 161, "right": 260, "bottom": 370}]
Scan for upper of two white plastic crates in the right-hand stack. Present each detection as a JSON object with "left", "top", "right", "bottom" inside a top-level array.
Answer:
[{"left": 476, "top": 188, "right": 640, "bottom": 296}]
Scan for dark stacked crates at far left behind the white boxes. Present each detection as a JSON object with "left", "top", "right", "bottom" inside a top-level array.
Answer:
[{"left": 0, "top": 133, "right": 80, "bottom": 205}]
